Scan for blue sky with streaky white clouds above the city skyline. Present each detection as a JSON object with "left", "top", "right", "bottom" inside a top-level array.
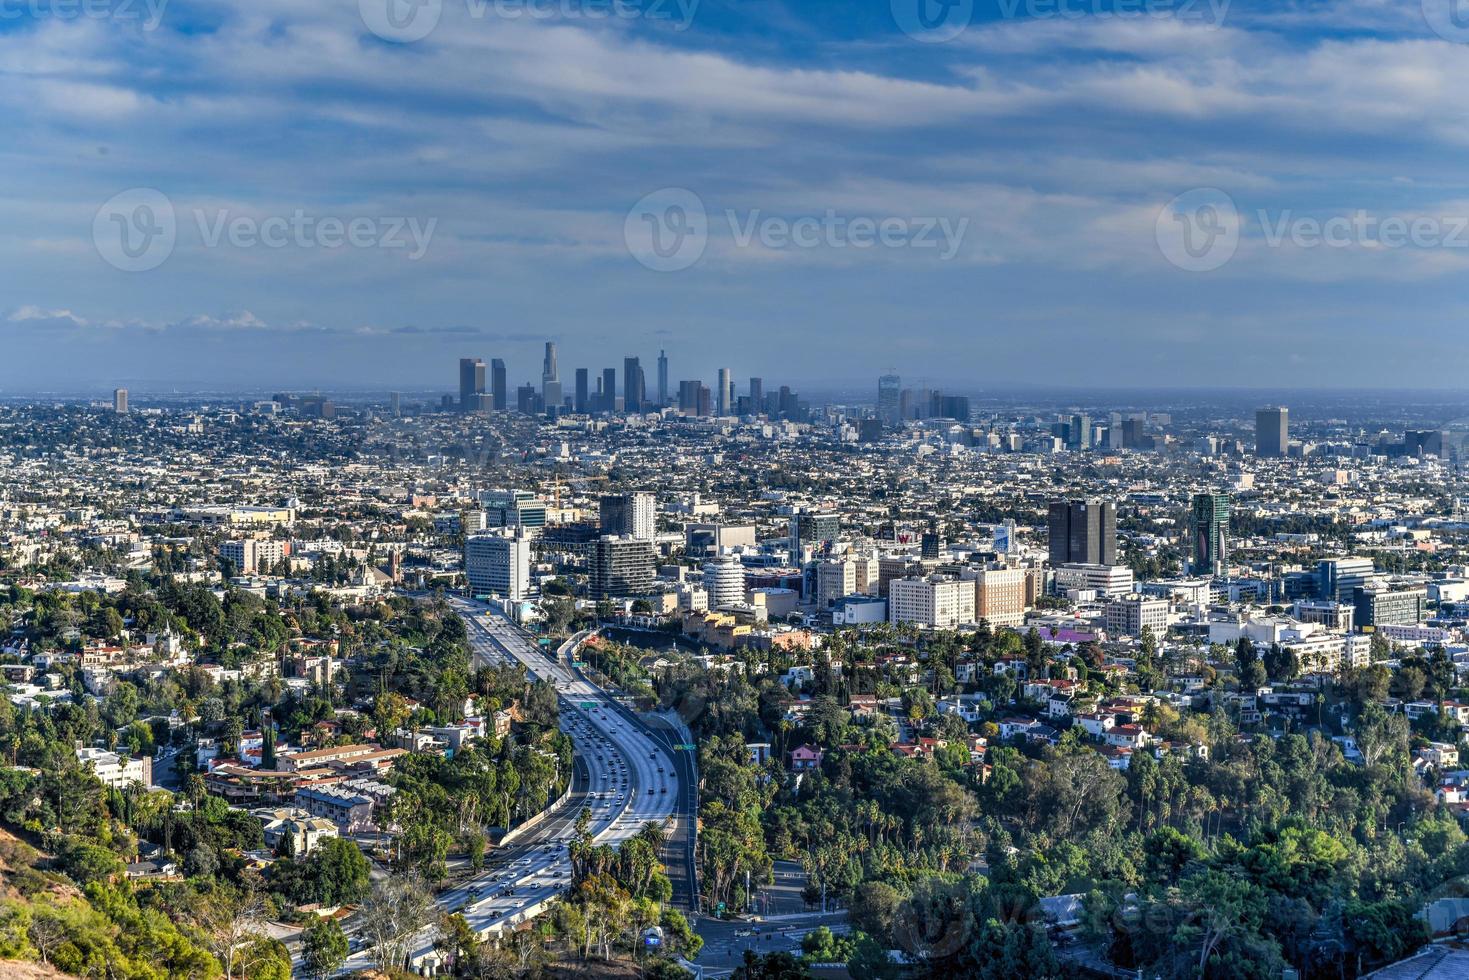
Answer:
[{"left": 0, "top": 0, "right": 1469, "bottom": 392}]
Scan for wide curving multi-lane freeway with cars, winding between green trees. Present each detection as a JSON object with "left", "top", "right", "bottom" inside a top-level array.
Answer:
[{"left": 355, "top": 598, "right": 687, "bottom": 974}]
